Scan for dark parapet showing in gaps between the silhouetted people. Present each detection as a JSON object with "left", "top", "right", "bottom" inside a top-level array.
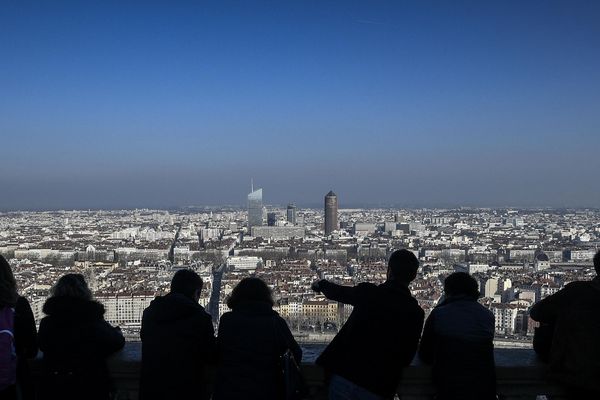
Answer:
[{"left": 32, "top": 342, "right": 565, "bottom": 400}]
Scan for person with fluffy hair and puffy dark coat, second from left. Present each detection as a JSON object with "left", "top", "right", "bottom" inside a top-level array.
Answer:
[{"left": 39, "top": 274, "right": 125, "bottom": 400}]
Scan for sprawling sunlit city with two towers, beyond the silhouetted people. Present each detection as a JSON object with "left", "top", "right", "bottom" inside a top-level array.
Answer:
[{"left": 0, "top": 187, "right": 600, "bottom": 347}]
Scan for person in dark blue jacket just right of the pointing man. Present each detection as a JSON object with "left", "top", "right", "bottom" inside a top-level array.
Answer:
[{"left": 419, "top": 272, "right": 496, "bottom": 400}]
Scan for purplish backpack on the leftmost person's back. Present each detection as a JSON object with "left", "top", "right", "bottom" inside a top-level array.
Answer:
[{"left": 0, "top": 306, "right": 17, "bottom": 390}]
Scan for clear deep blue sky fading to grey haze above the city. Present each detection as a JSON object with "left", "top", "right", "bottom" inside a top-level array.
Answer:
[{"left": 0, "top": 0, "right": 600, "bottom": 210}]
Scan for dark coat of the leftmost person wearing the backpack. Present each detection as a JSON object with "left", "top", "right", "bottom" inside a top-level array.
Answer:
[{"left": 0, "top": 296, "right": 38, "bottom": 400}]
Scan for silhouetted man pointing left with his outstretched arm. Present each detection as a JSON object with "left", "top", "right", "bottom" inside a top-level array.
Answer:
[{"left": 313, "top": 250, "right": 423, "bottom": 399}]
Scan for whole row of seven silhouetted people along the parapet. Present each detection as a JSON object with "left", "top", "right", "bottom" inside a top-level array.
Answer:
[{"left": 0, "top": 250, "right": 600, "bottom": 400}]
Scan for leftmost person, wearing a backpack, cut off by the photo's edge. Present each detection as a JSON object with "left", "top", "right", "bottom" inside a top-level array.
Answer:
[{"left": 0, "top": 255, "right": 38, "bottom": 400}]
